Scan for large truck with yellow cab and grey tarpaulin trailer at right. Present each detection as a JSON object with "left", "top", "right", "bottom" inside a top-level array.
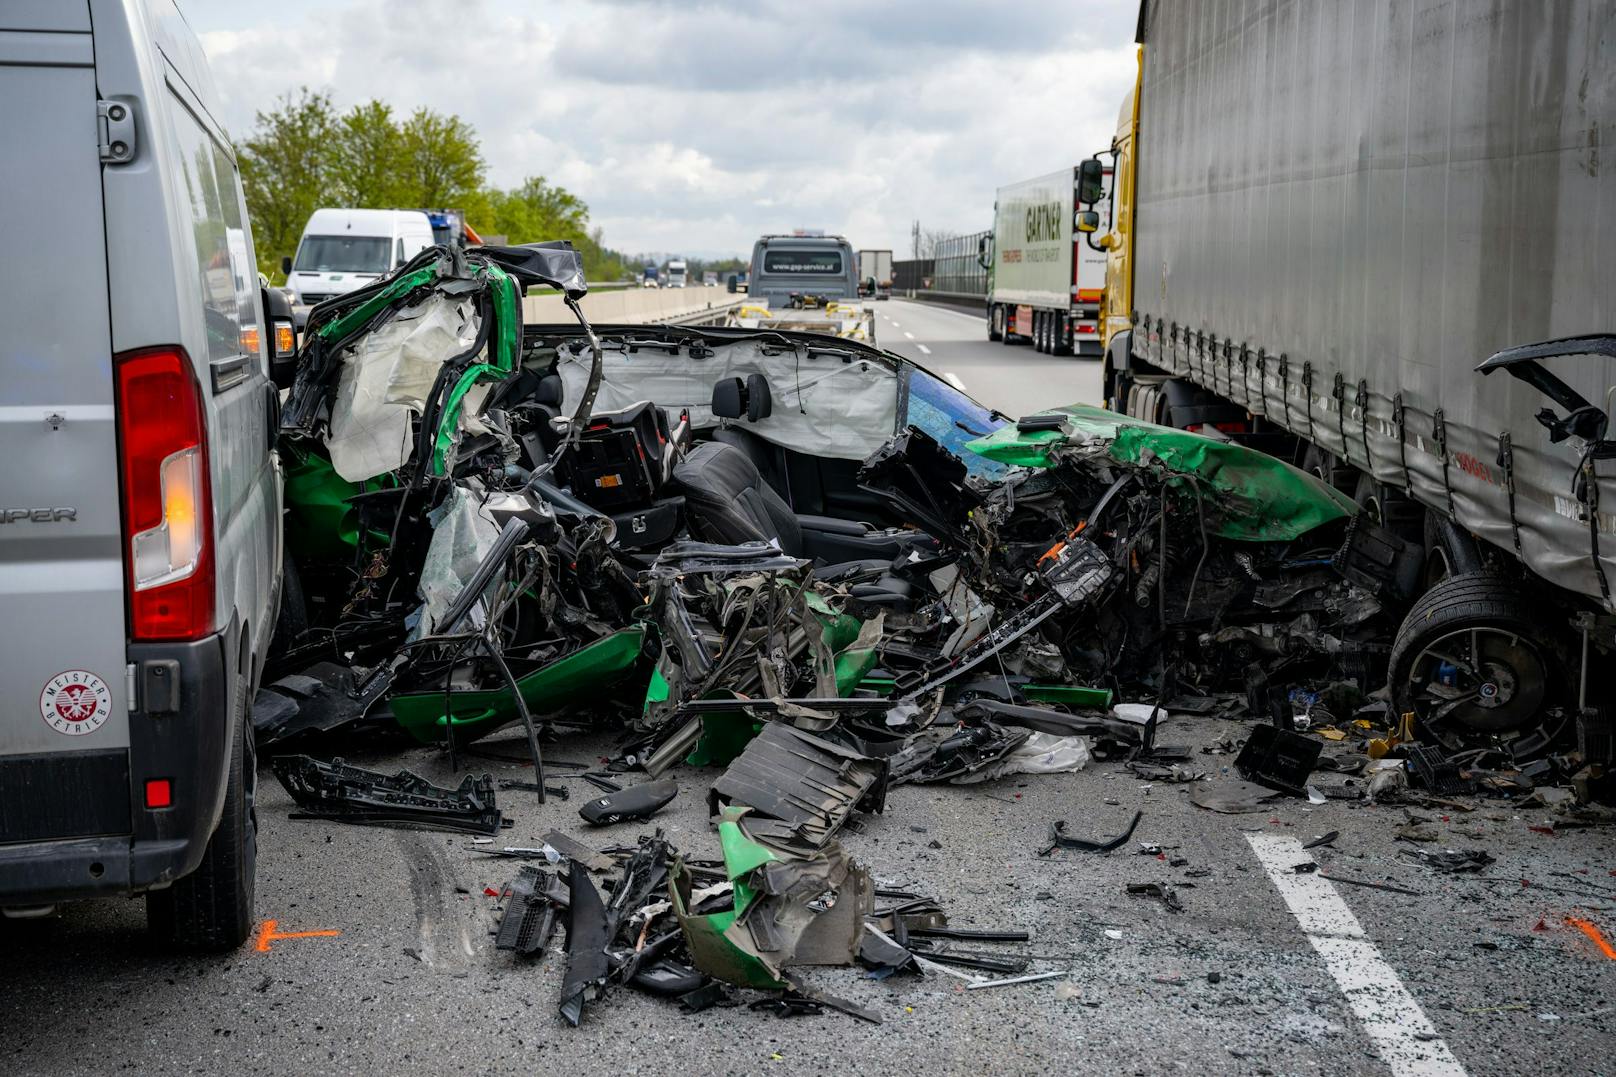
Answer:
[{"left": 1085, "top": 0, "right": 1616, "bottom": 753}]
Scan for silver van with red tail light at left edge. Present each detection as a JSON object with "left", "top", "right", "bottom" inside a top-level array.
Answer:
[{"left": 0, "top": 0, "right": 291, "bottom": 949}]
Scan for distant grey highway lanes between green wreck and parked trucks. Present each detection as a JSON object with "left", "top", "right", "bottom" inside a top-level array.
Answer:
[{"left": 874, "top": 299, "right": 1100, "bottom": 419}]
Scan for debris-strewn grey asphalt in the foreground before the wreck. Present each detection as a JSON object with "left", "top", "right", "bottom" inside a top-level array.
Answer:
[{"left": 0, "top": 716, "right": 1616, "bottom": 1074}]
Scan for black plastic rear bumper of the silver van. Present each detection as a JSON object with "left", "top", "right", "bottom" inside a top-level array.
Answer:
[{"left": 0, "top": 634, "right": 242, "bottom": 906}]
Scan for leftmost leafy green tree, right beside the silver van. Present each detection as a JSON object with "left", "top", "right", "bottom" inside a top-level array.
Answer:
[{"left": 236, "top": 86, "right": 336, "bottom": 280}]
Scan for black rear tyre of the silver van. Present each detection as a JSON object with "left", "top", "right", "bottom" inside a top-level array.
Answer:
[{"left": 145, "top": 673, "right": 259, "bottom": 952}]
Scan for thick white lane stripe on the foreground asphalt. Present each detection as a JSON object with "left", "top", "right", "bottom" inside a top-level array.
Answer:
[{"left": 1246, "top": 834, "right": 1464, "bottom": 1077}]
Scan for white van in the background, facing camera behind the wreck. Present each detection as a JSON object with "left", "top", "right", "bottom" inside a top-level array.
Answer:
[{"left": 281, "top": 209, "right": 436, "bottom": 318}]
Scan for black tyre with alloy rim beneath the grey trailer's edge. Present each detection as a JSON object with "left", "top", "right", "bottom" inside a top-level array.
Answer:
[{"left": 1390, "top": 572, "right": 1568, "bottom": 749}]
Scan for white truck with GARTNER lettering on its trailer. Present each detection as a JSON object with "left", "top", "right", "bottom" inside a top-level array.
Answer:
[{"left": 981, "top": 168, "right": 1107, "bottom": 357}]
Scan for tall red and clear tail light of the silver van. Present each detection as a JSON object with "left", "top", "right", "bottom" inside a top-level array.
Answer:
[{"left": 116, "top": 348, "right": 213, "bottom": 640}]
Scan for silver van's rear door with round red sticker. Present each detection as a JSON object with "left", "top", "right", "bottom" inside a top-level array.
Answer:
[{"left": 0, "top": 0, "right": 129, "bottom": 844}]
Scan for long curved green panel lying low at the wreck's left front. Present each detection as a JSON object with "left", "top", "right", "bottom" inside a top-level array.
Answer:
[{"left": 393, "top": 627, "right": 645, "bottom": 744}]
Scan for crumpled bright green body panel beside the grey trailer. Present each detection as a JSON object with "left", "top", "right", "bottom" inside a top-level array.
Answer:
[{"left": 966, "top": 404, "right": 1357, "bottom": 542}]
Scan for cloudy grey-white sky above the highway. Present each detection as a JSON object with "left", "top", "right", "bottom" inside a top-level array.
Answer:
[{"left": 179, "top": 0, "right": 1138, "bottom": 257}]
